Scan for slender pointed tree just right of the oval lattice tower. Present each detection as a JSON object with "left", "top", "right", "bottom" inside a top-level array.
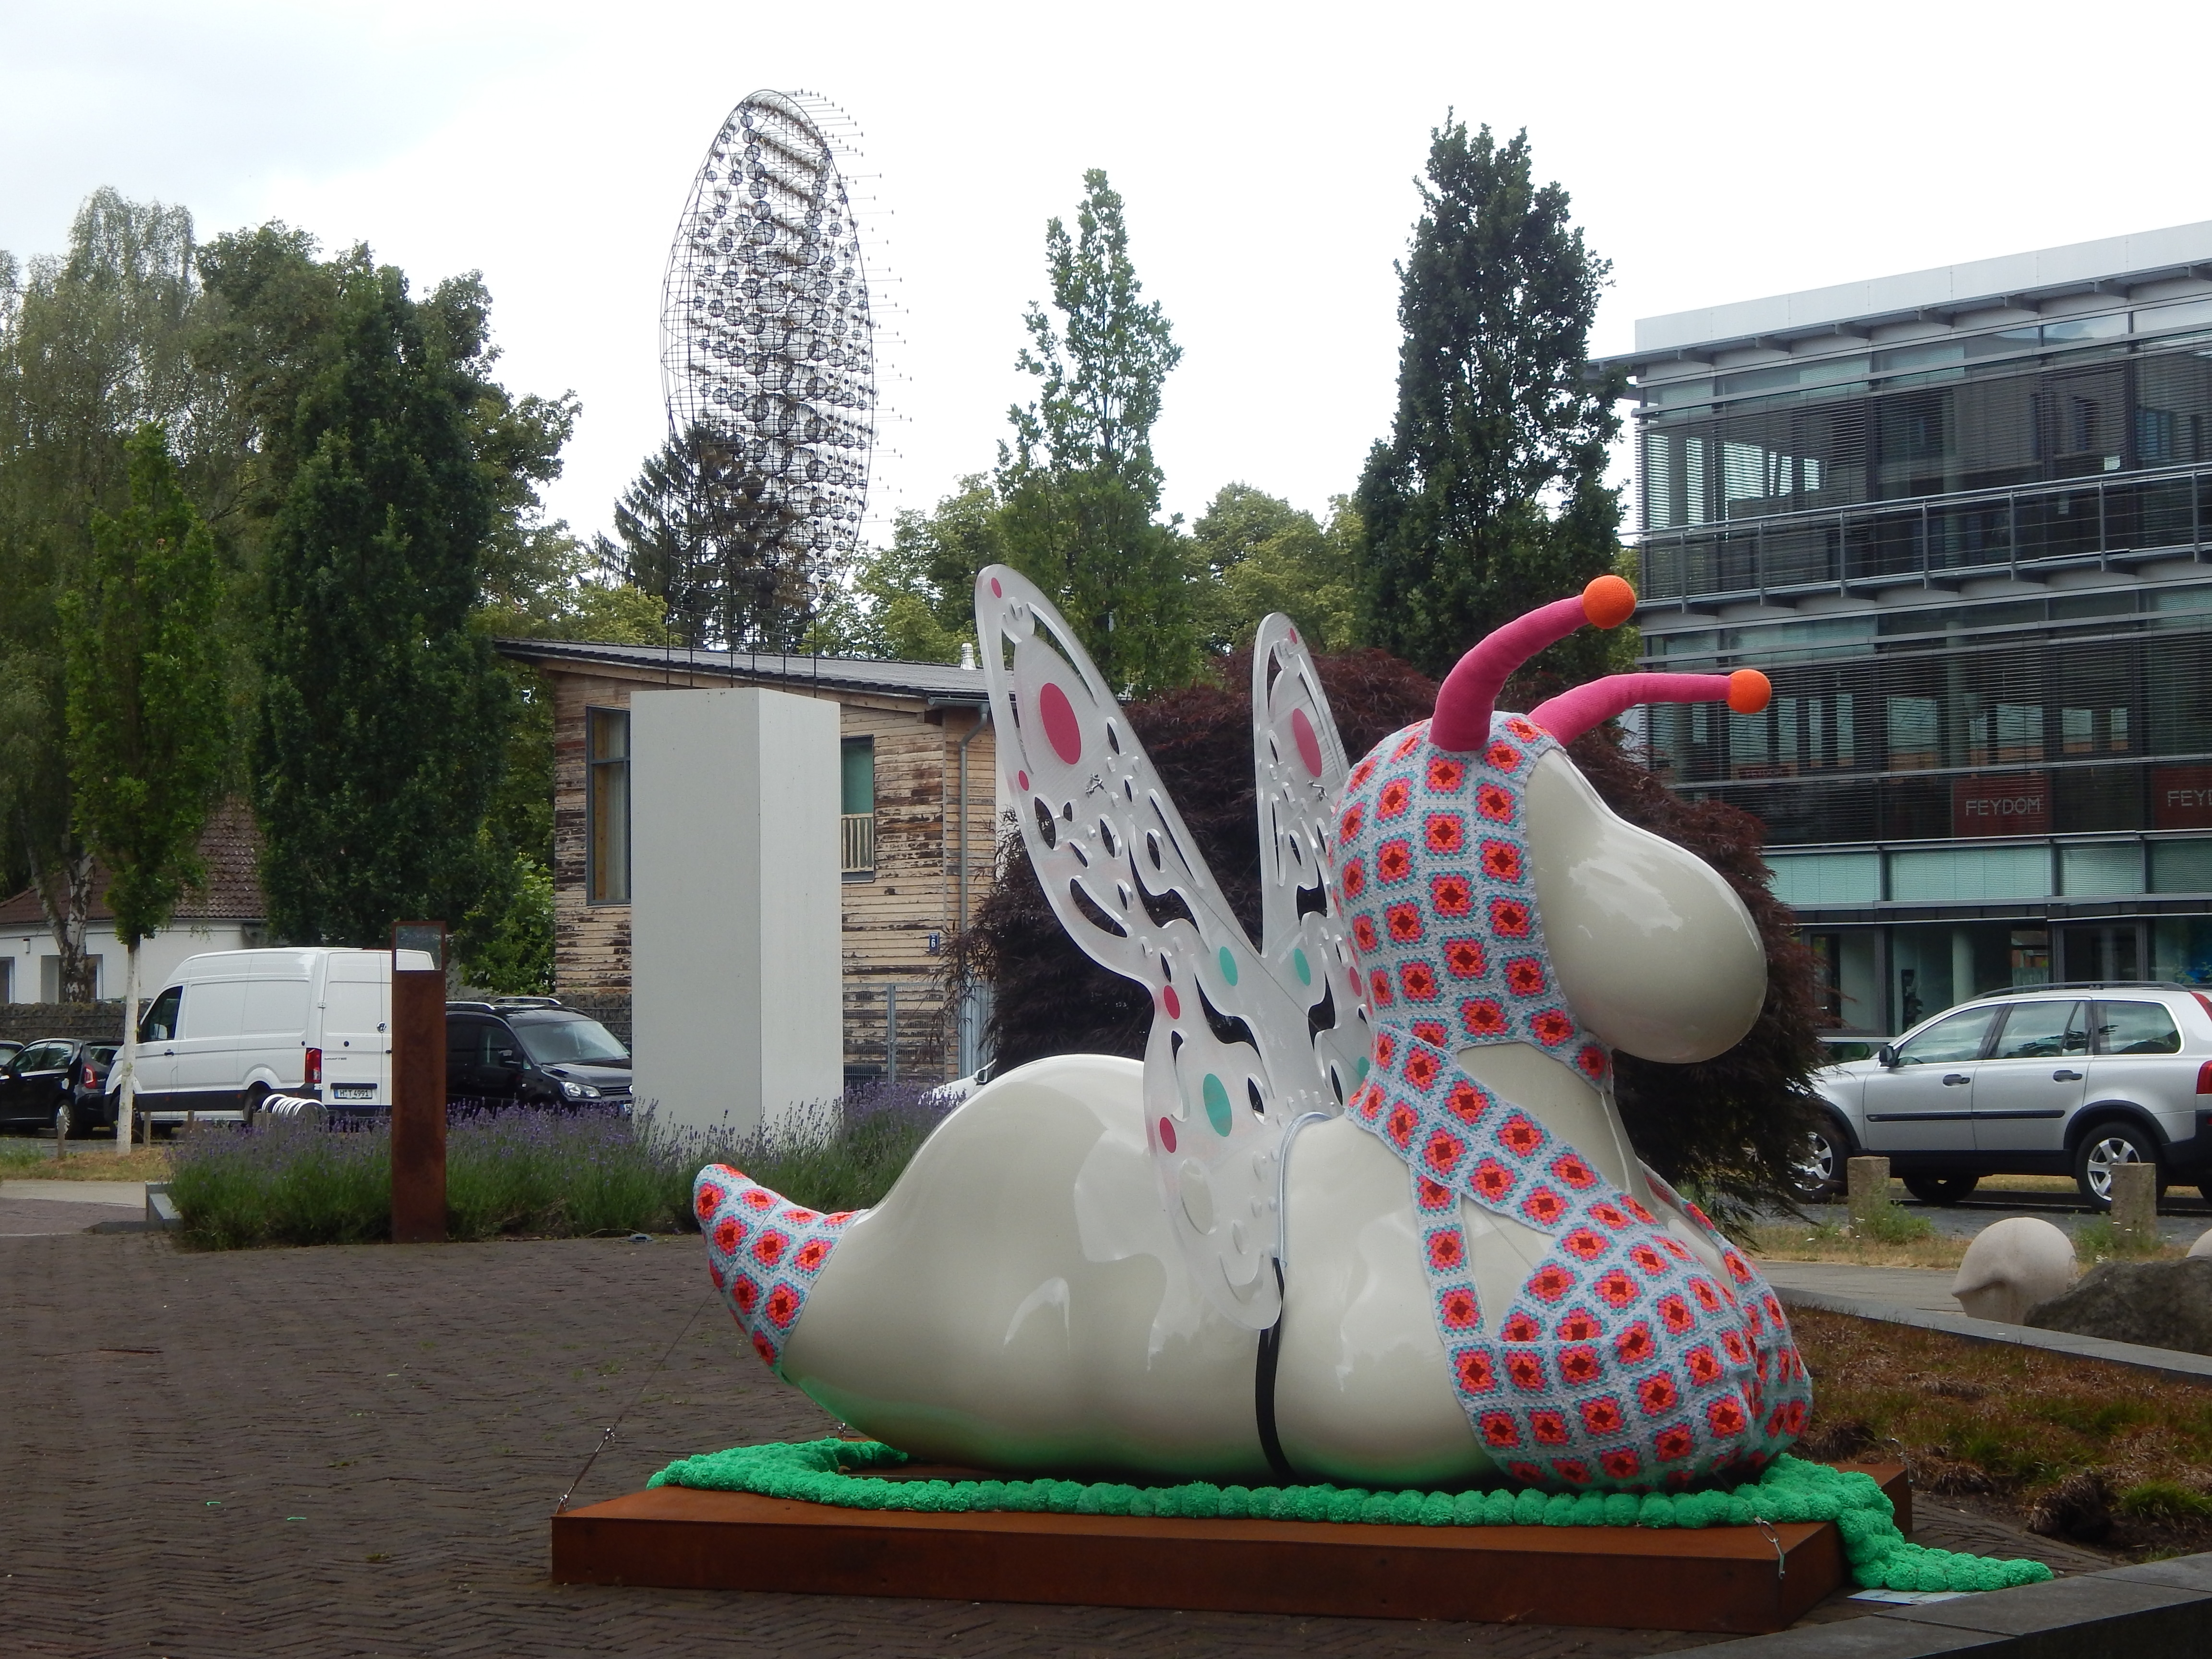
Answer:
[{"left": 998, "top": 168, "right": 1199, "bottom": 692}]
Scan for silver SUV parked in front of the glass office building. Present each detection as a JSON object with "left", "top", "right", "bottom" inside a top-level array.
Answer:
[{"left": 1801, "top": 982, "right": 2212, "bottom": 1210}]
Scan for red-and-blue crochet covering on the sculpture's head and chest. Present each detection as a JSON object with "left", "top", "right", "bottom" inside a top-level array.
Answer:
[{"left": 1336, "top": 714, "right": 1812, "bottom": 1491}]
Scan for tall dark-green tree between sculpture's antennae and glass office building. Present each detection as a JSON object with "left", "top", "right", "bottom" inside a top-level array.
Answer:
[{"left": 1356, "top": 120, "right": 1622, "bottom": 677}]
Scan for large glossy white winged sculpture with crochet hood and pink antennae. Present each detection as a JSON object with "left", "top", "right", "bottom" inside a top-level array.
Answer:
[{"left": 697, "top": 568, "right": 1807, "bottom": 1491}]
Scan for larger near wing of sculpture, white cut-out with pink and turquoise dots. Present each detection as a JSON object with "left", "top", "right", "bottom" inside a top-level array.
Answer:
[{"left": 975, "top": 566, "right": 1327, "bottom": 1329}]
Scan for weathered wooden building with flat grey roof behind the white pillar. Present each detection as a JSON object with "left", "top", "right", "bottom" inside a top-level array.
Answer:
[{"left": 500, "top": 639, "right": 998, "bottom": 1082}]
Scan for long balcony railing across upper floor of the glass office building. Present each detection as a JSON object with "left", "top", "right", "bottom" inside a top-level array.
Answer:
[{"left": 1639, "top": 467, "right": 2212, "bottom": 604}]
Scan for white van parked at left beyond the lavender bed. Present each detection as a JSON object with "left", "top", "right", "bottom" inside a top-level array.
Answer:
[{"left": 110, "top": 947, "right": 433, "bottom": 1124}]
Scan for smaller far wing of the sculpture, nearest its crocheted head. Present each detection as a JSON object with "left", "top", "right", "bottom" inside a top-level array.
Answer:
[{"left": 1252, "top": 613, "right": 1369, "bottom": 1110}]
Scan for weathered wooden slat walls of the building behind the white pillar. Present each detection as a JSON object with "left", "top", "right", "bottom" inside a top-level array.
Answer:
[{"left": 544, "top": 666, "right": 998, "bottom": 1080}]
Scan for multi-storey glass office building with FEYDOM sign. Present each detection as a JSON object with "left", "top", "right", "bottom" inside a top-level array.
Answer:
[{"left": 1615, "top": 223, "right": 2212, "bottom": 1033}]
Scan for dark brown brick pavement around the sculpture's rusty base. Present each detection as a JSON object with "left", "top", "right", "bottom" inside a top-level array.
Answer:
[{"left": 0, "top": 1234, "right": 2104, "bottom": 1659}]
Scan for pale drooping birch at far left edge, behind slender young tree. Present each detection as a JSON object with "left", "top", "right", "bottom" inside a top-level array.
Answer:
[{"left": 0, "top": 190, "right": 206, "bottom": 1002}]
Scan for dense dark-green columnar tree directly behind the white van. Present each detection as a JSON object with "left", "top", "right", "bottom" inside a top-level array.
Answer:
[{"left": 254, "top": 250, "right": 511, "bottom": 945}]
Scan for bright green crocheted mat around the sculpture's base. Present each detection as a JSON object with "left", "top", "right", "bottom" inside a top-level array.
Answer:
[{"left": 646, "top": 1440, "right": 2051, "bottom": 1590}]
